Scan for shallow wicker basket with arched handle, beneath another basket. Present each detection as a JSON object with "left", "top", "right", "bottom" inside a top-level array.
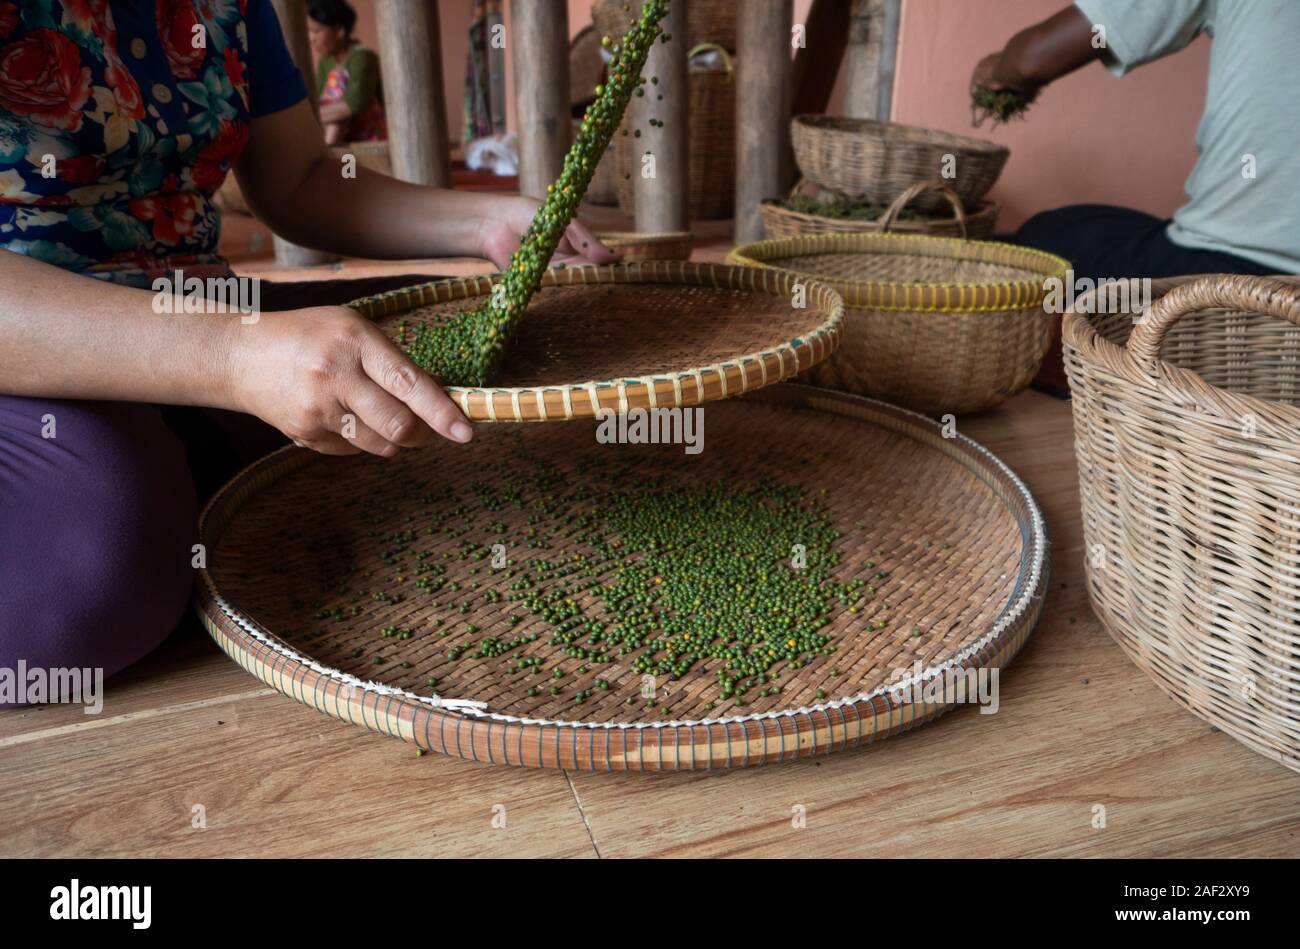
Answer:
[{"left": 758, "top": 179, "right": 998, "bottom": 239}]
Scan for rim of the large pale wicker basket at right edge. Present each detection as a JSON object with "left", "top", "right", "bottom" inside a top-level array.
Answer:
[{"left": 1061, "top": 274, "right": 1300, "bottom": 441}]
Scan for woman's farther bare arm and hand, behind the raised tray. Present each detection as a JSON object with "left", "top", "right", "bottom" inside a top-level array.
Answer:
[{"left": 235, "top": 101, "right": 618, "bottom": 269}]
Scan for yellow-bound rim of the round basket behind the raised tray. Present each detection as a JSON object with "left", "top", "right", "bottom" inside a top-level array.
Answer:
[{"left": 727, "top": 231, "right": 1070, "bottom": 313}]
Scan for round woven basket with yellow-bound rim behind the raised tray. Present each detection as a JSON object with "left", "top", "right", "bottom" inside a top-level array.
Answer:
[{"left": 727, "top": 234, "right": 1069, "bottom": 415}]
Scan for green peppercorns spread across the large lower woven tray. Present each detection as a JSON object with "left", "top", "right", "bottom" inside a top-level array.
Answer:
[{"left": 308, "top": 441, "right": 888, "bottom": 715}]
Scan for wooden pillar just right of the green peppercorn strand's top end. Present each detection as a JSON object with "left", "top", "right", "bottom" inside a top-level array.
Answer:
[{"left": 632, "top": 0, "right": 690, "bottom": 233}]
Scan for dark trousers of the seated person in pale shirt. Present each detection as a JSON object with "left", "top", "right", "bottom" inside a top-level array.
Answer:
[{"left": 1004, "top": 204, "right": 1273, "bottom": 395}]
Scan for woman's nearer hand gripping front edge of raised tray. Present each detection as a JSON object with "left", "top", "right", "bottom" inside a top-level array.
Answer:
[{"left": 230, "top": 307, "right": 473, "bottom": 449}]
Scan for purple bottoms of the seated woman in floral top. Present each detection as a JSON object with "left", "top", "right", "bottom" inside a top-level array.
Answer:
[{"left": 0, "top": 276, "right": 433, "bottom": 707}]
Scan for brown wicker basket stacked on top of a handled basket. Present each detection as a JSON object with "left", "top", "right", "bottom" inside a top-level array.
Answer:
[{"left": 790, "top": 116, "right": 1010, "bottom": 211}]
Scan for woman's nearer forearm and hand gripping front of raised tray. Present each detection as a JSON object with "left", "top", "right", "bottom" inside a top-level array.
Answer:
[{"left": 0, "top": 251, "right": 473, "bottom": 456}]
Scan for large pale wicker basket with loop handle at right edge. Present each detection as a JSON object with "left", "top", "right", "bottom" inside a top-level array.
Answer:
[{"left": 1063, "top": 276, "right": 1300, "bottom": 771}]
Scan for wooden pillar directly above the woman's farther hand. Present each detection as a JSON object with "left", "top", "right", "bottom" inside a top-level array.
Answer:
[{"left": 507, "top": 0, "right": 573, "bottom": 199}]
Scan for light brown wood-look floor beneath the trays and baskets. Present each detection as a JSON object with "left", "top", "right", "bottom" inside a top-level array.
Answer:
[{"left": 0, "top": 231, "right": 1300, "bottom": 857}]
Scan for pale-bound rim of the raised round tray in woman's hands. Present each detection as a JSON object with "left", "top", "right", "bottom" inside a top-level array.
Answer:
[{"left": 347, "top": 260, "right": 845, "bottom": 421}]
